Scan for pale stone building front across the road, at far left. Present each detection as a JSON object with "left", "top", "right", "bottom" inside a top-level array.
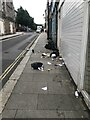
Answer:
[{"left": 0, "top": 0, "right": 15, "bottom": 34}]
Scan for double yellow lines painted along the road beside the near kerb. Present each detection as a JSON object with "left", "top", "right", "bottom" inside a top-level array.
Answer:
[{"left": 0, "top": 36, "right": 38, "bottom": 81}]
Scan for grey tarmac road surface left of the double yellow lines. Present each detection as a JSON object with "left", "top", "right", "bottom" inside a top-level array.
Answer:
[{"left": 2, "top": 33, "right": 36, "bottom": 73}]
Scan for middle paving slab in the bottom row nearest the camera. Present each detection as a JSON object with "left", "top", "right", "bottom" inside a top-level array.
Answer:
[{"left": 15, "top": 110, "right": 64, "bottom": 118}]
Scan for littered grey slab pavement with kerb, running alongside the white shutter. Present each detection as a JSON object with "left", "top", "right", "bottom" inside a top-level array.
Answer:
[{"left": 0, "top": 33, "right": 90, "bottom": 120}]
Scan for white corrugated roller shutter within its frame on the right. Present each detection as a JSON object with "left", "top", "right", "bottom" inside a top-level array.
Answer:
[{"left": 61, "top": 0, "right": 84, "bottom": 84}]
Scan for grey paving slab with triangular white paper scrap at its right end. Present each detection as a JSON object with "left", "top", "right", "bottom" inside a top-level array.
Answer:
[{"left": 13, "top": 81, "right": 48, "bottom": 94}]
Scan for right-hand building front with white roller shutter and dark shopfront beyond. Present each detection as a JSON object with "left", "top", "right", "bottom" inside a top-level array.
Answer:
[{"left": 47, "top": 0, "right": 90, "bottom": 109}]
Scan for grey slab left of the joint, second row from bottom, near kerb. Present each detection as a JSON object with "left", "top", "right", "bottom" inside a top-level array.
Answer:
[{"left": 6, "top": 94, "right": 38, "bottom": 110}]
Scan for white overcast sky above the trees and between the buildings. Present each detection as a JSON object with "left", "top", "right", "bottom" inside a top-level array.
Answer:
[{"left": 13, "top": 0, "right": 47, "bottom": 24}]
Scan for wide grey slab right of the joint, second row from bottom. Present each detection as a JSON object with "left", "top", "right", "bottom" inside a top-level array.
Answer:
[{"left": 38, "top": 94, "right": 86, "bottom": 111}]
